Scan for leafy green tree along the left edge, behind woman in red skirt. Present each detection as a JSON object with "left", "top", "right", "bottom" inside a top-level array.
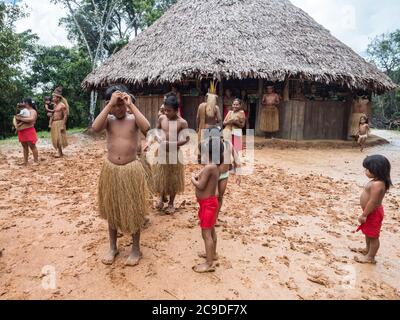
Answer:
[{"left": 0, "top": 2, "right": 37, "bottom": 137}]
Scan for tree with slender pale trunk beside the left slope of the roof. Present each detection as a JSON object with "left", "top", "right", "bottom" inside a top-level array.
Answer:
[{"left": 52, "top": 0, "right": 175, "bottom": 125}]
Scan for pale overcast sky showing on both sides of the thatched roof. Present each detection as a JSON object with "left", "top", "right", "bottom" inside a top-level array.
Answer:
[{"left": 14, "top": 0, "right": 400, "bottom": 55}]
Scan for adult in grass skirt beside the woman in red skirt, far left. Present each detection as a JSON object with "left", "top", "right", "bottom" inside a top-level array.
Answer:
[{"left": 51, "top": 88, "right": 69, "bottom": 158}]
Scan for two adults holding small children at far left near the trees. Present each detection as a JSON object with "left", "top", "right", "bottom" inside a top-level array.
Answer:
[{"left": 13, "top": 87, "right": 69, "bottom": 166}]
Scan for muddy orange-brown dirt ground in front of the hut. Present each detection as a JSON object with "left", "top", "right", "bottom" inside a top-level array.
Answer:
[{"left": 0, "top": 131, "right": 400, "bottom": 299}]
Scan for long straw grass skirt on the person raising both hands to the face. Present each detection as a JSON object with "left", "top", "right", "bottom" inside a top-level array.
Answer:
[{"left": 98, "top": 160, "right": 149, "bottom": 234}]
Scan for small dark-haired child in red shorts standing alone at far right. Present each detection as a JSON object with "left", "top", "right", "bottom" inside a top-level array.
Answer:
[{"left": 352, "top": 155, "right": 392, "bottom": 264}]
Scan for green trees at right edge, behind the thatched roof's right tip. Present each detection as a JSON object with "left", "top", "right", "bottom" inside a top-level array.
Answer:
[{"left": 367, "top": 30, "right": 400, "bottom": 129}]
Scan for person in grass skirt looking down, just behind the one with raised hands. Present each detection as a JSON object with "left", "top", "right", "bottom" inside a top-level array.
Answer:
[{"left": 154, "top": 96, "right": 190, "bottom": 214}]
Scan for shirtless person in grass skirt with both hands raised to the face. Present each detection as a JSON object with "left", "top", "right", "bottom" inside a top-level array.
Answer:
[{"left": 92, "top": 86, "right": 150, "bottom": 266}]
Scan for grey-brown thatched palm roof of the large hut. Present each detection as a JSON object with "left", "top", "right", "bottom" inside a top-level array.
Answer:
[{"left": 82, "top": 0, "right": 395, "bottom": 93}]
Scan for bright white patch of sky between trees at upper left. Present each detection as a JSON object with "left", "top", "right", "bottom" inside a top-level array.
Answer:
[{"left": 16, "top": 0, "right": 72, "bottom": 47}]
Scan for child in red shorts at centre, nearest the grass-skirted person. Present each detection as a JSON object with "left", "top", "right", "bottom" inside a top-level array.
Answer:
[{"left": 192, "top": 136, "right": 224, "bottom": 273}]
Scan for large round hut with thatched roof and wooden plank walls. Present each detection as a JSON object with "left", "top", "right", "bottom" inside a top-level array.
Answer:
[{"left": 82, "top": 0, "right": 396, "bottom": 140}]
